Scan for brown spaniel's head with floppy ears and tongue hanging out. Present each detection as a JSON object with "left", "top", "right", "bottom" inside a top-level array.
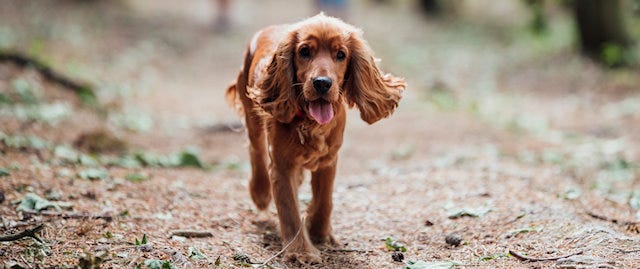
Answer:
[{"left": 257, "top": 14, "right": 405, "bottom": 124}]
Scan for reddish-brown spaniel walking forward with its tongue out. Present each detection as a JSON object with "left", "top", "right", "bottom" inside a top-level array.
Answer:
[{"left": 226, "top": 13, "right": 406, "bottom": 264}]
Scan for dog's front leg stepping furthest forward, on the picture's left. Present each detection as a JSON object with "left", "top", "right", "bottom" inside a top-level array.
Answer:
[{"left": 271, "top": 164, "right": 321, "bottom": 263}]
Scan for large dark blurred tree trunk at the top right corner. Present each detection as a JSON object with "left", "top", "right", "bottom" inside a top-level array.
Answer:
[{"left": 574, "top": 0, "right": 634, "bottom": 66}]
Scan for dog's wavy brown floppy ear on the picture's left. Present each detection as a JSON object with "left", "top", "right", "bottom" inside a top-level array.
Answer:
[{"left": 249, "top": 32, "right": 298, "bottom": 123}]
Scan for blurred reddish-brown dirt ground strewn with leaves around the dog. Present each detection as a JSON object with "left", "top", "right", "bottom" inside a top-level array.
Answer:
[{"left": 0, "top": 0, "right": 640, "bottom": 268}]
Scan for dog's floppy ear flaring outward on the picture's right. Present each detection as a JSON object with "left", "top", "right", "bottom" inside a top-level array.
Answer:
[{"left": 343, "top": 32, "right": 406, "bottom": 124}]
